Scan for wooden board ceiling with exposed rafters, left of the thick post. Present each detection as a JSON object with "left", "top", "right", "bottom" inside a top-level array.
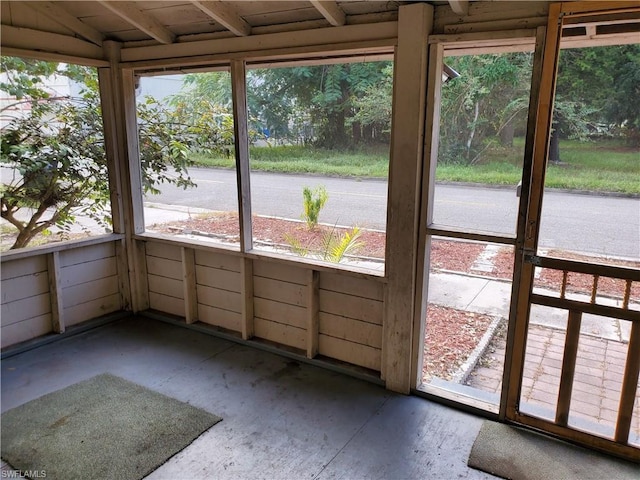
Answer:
[{"left": 1, "top": 0, "right": 418, "bottom": 46}]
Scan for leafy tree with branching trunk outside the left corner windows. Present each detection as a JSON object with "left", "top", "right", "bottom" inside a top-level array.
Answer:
[{"left": 0, "top": 57, "right": 226, "bottom": 248}]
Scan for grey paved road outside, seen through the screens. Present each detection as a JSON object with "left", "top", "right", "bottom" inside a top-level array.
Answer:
[{"left": 147, "top": 168, "right": 640, "bottom": 259}]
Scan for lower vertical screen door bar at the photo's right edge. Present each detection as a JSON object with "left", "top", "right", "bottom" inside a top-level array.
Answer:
[{"left": 615, "top": 321, "right": 640, "bottom": 444}]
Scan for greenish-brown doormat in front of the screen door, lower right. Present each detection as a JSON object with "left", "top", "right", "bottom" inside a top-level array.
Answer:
[{"left": 467, "top": 421, "right": 639, "bottom": 480}]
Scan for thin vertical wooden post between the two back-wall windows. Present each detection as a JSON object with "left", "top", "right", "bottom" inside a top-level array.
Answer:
[{"left": 231, "top": 60, "right": 253, "bottom": 252}]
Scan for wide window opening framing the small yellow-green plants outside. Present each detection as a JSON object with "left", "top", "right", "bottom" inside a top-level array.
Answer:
[{"left": 247, "top": 61, "right": 393, "bottom": 274}]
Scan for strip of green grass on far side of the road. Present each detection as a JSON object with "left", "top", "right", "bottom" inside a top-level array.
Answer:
[{"left": 188, "top": 139, "right": 640, "bottom": 195}]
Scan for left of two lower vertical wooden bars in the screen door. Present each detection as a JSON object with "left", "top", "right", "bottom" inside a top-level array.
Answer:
[{"left": 556, "top": 310, "right": 582, "bottom": 427}]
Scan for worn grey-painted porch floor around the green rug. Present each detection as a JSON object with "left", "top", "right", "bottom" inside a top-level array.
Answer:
[{"left": 1, "top": 318, "right": 496, "bottom": 480}]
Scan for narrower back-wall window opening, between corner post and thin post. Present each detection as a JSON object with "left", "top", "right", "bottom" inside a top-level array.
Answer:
[{"left": 136, "top": 71, "right": 240, "bottom": 249}]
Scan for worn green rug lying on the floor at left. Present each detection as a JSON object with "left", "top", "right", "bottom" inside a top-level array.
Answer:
[{"left": 2, "top": 374, "right": 222, "bottom": 480}]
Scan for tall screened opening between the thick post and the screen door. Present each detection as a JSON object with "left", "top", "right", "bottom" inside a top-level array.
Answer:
[{"left": 419, "top": 50, "right": 533, "bottom": 413}]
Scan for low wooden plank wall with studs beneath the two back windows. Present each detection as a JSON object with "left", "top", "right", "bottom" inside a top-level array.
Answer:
[{"left": 138, "top": 239, "right": 385, "bottom": 372}]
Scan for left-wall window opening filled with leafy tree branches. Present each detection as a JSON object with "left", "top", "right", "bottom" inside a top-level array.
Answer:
[{"left": 0, "top": 56, "right": 111, "bottom": 251}]
